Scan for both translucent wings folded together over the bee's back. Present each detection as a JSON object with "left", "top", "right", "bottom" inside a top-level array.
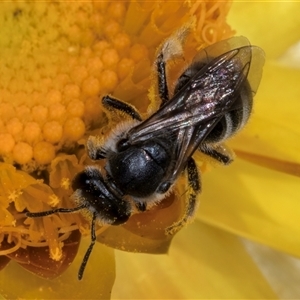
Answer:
[{"left": 129, "top": 37, "right": 264, "bottom": 178}]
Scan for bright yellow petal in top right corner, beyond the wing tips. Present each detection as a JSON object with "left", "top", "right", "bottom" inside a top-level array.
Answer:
[{"left": 228, "top": 0, "right": 300, "bottom": 59}]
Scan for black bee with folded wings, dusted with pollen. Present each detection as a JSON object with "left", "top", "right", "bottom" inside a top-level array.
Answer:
[{"left": 27, "top": 30, "right": 264, "bottom": 280}]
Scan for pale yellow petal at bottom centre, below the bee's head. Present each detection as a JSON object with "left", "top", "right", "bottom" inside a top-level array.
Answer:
[{"left": 112, "top": 221, "right": 276, "bottom": 299}]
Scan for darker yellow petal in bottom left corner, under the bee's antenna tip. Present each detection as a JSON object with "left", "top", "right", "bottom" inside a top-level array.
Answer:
[{"left": 0, "top": 239, "right": 115, "bottom": 299}]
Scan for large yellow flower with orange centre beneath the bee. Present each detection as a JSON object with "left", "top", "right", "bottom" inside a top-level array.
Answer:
[{"left": 0, "top": 1, "right": 300, "bottom": 299}]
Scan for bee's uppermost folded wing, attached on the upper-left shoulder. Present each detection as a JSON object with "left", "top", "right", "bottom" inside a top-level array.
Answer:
[{"left": 129, "top": 42, "right": 261, "bottom": 143}]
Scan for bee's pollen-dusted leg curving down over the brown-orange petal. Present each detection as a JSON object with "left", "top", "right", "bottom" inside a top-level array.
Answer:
[{"left": 166, "top": 157, "right": 201, "bottom": 235}]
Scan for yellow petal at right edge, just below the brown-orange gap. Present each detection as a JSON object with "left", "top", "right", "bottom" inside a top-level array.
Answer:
[{"left": 198, "top": 159, "right": 300, "bottom": 256}]
